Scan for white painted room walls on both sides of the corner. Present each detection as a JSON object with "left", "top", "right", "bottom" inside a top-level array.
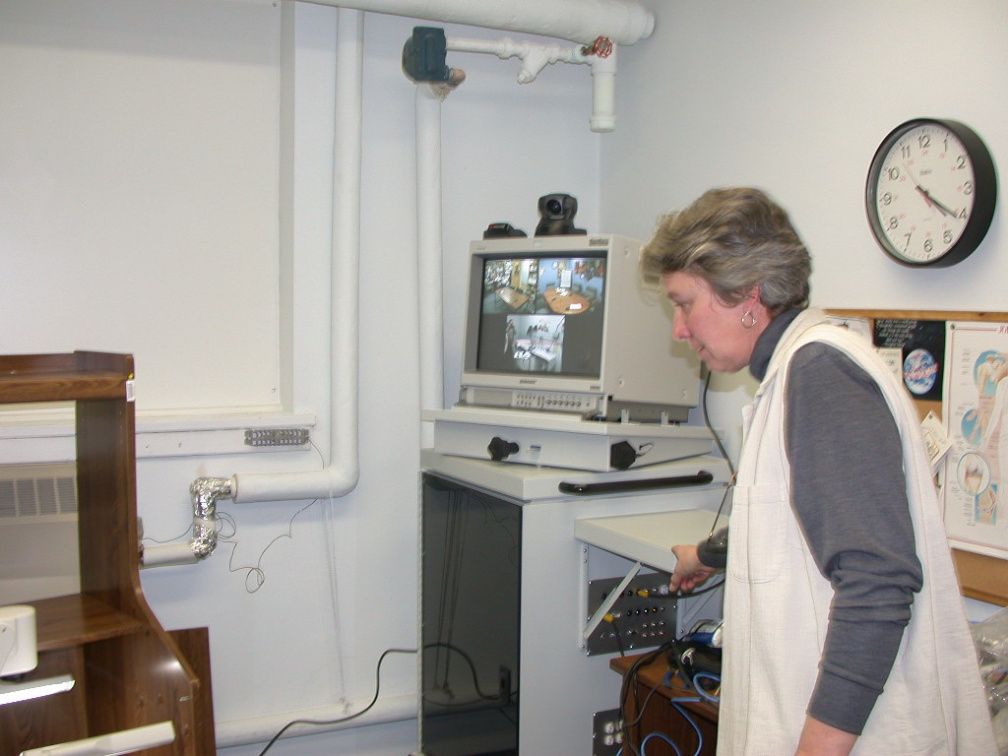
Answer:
[{"left": 0, "top": 0, "right": 1008, "bottom": 756}]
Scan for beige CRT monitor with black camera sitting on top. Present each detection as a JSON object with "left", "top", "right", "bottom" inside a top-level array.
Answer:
[{"left": 460, "top": 235, "right": 700, "bottom": 422}]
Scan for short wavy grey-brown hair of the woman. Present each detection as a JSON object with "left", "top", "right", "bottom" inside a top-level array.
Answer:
[{"left": 641, "top": 187, "right": 811, "bottom": 314}]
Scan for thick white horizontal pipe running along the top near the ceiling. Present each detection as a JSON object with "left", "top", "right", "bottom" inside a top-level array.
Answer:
[{"left": 298, "top": 0, "right": 654, "bottom": 44}]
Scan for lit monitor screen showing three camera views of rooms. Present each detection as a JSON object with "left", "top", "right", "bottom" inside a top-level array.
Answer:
[{"left": 476, "top": 252, "right": 606, "bottom": 378}]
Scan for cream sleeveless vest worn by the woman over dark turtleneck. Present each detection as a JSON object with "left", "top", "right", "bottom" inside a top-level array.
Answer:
[{"left": 718, "top": 309, "right": 997, "bottom": 756}]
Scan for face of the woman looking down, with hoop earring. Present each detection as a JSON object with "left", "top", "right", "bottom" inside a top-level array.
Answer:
[{"left": 661, "top": 271, "right": 769, "bottom": 373}]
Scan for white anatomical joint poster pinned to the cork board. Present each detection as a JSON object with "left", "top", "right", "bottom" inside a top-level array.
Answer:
[{"left": 941, "top": 322, "right": 1008, "bottom": 558}]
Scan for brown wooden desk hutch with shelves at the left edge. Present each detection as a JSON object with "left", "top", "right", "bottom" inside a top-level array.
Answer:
[{"left": 0, "top": 352, "right": 215, "bottom": 756}]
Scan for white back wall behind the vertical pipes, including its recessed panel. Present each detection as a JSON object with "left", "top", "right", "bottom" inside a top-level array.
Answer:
[{"left": 0, "top": 0, "right": 599, "bottom": 756}]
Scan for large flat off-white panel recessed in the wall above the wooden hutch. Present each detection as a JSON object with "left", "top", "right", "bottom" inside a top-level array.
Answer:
[{"left": 0, "top": 0, "right": 279, "bottom": 408}]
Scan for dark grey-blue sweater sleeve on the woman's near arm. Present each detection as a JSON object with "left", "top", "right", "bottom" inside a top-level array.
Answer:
[{"left": 786, "top": 344, "right": 922, "bottom": 734}]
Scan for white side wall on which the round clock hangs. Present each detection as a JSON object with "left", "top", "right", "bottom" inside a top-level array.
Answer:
[{"left": 601, "top": 0, "right": 1008, "bottom": 467}]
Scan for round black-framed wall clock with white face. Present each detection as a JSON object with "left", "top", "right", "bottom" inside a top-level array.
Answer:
[{"left": 865, "top": 118, "right": 998, "bottom": 267}]
